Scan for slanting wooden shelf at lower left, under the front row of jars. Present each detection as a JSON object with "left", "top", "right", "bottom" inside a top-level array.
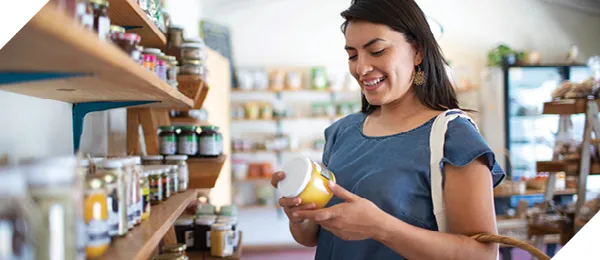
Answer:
[{"left": 97, "top": 190, "right": 197, "bottom": 260}]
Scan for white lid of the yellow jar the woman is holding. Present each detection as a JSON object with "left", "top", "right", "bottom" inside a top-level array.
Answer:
[{"left": 277, "top": 157, "right": 312, "bottom": 198}]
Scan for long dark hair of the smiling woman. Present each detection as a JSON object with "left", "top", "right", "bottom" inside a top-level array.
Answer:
[{"left": 341, "top": 0, "right": 460, "bottom": 113}]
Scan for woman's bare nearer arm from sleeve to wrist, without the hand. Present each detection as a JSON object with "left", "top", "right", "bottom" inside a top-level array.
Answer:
[{"left": 373, "top": 158, "right": 498, "bottom": 260}]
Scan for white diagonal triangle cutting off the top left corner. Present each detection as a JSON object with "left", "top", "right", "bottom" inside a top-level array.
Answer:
[{"left": 0, "top": 0, "right": 48, "bottom": 49}]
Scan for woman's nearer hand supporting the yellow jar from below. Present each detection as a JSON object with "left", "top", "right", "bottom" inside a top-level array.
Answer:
[{"left": 293, "top": 182, "right": 385, "bottom": 240}]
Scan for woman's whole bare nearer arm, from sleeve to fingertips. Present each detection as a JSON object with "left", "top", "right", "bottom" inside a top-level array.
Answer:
[{"left": 293, "top": 156, "right": 498, "bottom": 260}]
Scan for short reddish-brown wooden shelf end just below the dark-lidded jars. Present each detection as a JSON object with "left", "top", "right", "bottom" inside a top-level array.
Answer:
[{"left": 187, "top": 155, "right": 227, "bottom": 189}]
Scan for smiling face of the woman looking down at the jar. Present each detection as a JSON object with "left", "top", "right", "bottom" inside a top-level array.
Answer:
[{"left": 345, "top": 21, "right": 422, "bottom": 106}]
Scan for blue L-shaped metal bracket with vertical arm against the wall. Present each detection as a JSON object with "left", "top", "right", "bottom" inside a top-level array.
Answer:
[{"left": 72, "top": 101, "right": 158, "bottom": 153}]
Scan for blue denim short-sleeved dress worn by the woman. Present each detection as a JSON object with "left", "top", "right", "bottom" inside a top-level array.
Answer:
[{"left": 315, "top": 113, "right": 505, "bottom": 260}]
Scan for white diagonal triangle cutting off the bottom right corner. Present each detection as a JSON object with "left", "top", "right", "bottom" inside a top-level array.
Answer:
[{"left": 552, "top": 214, "right": 600, "bottom": 260}]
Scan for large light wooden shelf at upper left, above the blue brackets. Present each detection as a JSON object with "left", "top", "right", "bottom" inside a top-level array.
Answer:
[{"left": 0, "top": 1, "right": 193, "bottom": 108}]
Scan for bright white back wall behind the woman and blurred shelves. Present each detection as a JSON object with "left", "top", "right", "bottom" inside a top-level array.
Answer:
[{"left": 202, "top": 0, "right": 600, "bottom": 245}]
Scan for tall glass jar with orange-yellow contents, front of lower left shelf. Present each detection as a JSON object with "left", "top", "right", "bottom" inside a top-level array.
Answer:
[{"left": 84, "top": 174, "right": 110, "bottom": 258}]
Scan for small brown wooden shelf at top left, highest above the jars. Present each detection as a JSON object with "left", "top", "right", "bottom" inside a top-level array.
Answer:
[{"left": 108, "top": 0, "right": 167, "bottom": 49}]
